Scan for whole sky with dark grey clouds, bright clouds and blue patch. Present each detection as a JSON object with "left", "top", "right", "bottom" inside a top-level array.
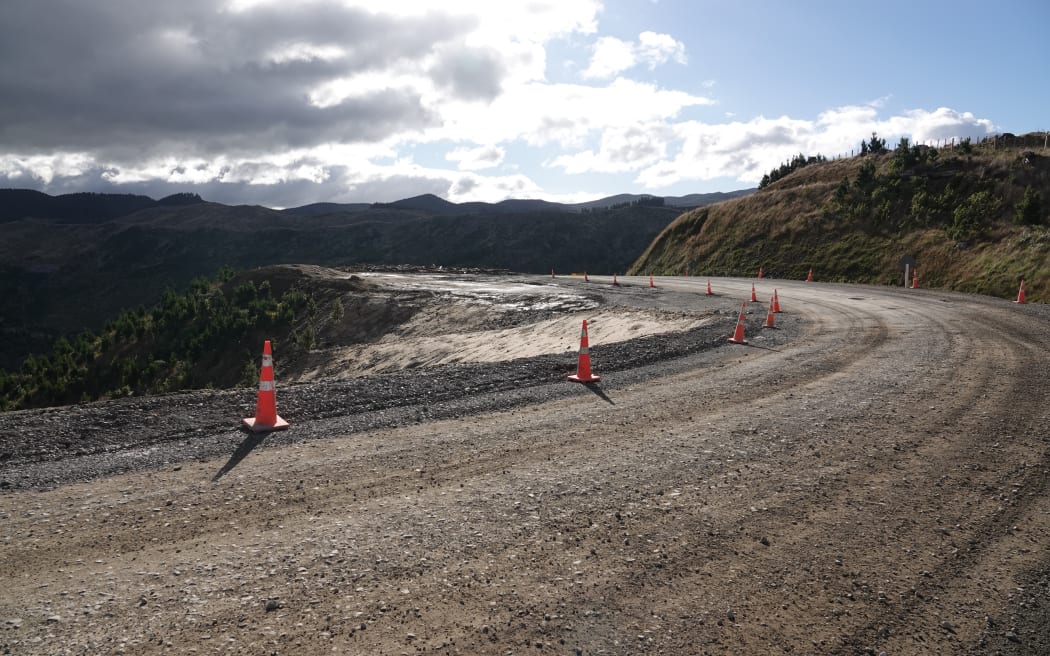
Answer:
[{"left": 0, "top": 0, "right": 1050, "bottom": 207}]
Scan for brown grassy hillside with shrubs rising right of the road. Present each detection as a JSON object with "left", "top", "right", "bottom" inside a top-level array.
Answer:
[{"left": 631, "top": 134, "right": 1050, "bottom": 302}]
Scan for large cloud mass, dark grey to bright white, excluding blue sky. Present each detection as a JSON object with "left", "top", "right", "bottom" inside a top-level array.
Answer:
[{"left": 0, "top": 0, "right": 994, "bottom": 207}]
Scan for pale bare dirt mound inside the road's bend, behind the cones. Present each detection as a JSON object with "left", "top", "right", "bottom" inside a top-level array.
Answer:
[{"left": 266, "top": 266, "right": 705, "bottom": 382}]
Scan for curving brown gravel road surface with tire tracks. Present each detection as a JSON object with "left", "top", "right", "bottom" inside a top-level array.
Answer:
[{"left": 0, "top": 277, "right": 1050, "bottom": 655}]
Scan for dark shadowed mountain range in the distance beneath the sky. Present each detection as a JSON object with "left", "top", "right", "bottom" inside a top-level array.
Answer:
[{"left": 0, "top": 189, "right": 753, "bottom": 368}]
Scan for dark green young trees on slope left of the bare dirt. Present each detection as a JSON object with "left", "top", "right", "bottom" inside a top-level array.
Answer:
[{"left": 0, "top": 268, "right": 317, "bottom": 410}]
